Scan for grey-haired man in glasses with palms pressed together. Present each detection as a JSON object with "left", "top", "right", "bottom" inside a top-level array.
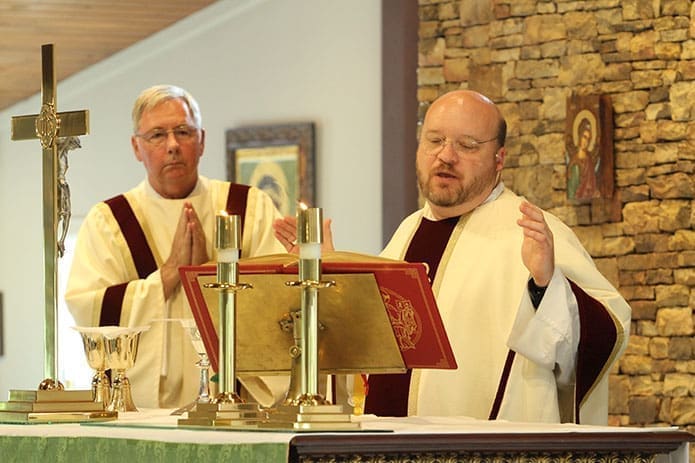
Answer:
[{"left": 66, "top": 85, "right": 284, "bottom": 408}]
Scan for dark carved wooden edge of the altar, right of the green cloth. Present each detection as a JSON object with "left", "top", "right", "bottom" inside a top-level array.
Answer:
[{"left": 289, "top": 431, "right": 693, "bottom": 463}]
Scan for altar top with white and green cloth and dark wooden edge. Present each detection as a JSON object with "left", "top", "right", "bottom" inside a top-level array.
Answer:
[{"left": 0, "top": 409, "right": 693, "bottom": 463}]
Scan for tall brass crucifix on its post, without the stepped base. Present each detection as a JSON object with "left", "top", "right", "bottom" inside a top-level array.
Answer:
[{"left": 12, "top": 44, "right": 89, "bottom": 389}]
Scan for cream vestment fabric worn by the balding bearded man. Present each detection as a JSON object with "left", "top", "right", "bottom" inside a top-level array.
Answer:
[{"left": 382, "top": 187, "right": 630, "bottom": 424}]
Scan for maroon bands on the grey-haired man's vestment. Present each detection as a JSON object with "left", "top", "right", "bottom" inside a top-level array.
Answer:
[{"left": 99, "top": 183, "right": 249, "bottom": 326}]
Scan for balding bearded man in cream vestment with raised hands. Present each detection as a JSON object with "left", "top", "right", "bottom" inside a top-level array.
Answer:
[{"left": 275, "top": 90, "right": 631, "bottom": 424}]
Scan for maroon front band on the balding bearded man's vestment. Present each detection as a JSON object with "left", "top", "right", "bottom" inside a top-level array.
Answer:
[{"left": 364, "top": 217, "right": 459, "bottom": 416}]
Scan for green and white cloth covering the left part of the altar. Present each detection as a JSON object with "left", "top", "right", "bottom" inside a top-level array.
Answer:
[{"left": 0, "top": 410, "right": 294, "bottom": 463}]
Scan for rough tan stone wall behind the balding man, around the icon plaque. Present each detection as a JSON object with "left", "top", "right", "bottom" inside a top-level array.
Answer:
[{"left": 418, "top": 0, "right": 695, "bottom": 444}]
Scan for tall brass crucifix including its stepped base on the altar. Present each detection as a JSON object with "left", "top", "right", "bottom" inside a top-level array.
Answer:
[{"left": 0, "top": 44, "right": 118, "bottom": 423}]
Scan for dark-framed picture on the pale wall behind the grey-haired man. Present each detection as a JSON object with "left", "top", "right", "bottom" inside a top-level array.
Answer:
[{"left": 226, "top": 122, "right": 316, "bottom": 216}]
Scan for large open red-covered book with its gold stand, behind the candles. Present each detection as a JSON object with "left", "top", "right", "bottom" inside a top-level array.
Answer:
[{"left": 179, "top": 251, "right": 456, "bottom": 375}]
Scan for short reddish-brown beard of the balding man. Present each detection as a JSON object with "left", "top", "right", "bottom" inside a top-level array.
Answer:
[{"left": 416, "top": 162, "right": 497, "bottom": 207}]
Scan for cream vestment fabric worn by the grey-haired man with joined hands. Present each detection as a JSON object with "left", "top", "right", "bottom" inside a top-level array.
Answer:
[{"left": 66, "top": 177, "right": 284, "bottom": 408}]
